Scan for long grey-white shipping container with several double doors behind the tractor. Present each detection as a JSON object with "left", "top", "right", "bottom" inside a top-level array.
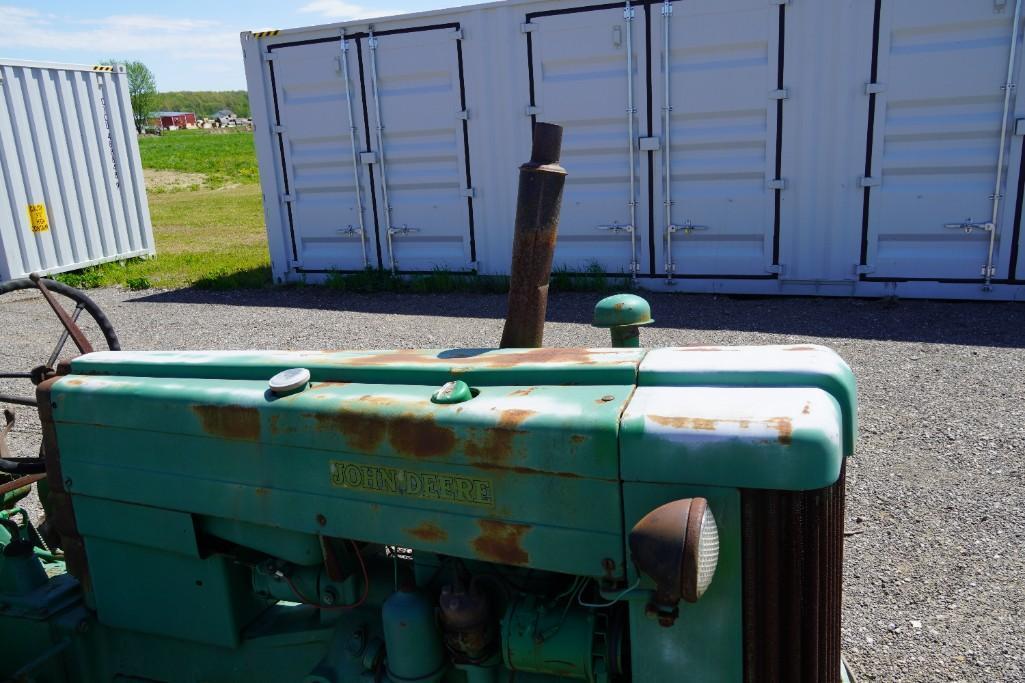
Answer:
[{"left": 242, "top": 0, "right": 1025, "bottom": 299}]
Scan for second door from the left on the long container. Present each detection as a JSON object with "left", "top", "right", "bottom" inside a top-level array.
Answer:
[{"left": 361, "top": 27, "right": 476, "bottom": 273}]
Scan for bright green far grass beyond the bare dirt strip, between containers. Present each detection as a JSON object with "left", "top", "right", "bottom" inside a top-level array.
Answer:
[{"left": 138, "top": 128, "right": 259, "bottom": 188}]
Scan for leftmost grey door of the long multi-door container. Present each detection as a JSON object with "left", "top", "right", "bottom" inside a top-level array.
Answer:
[{"left": 270, "top": 40, "right": 377, "bottom": 271}]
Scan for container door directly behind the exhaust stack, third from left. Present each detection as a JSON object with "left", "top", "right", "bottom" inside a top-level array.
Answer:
[{"left": 526, "top": 5, "right": 649, "bottom": 273}]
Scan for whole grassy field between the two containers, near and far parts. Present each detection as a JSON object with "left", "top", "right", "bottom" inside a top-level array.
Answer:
[{"left": 57, "top": 130, "right": 271, "bottom": 289}]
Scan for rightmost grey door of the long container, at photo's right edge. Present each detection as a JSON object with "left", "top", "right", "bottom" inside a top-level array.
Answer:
[{"left": 861, "top": 0, "right": 1021, "bottom": 280}]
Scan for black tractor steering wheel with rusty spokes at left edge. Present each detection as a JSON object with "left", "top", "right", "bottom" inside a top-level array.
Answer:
[{"left": 0, "top": 273, "right": 121, "bottom": 475}]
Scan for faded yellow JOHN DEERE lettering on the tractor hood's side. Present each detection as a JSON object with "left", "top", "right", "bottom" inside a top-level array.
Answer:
[{"left": 331, "top": 460, "right": 495, "bottom": 508}]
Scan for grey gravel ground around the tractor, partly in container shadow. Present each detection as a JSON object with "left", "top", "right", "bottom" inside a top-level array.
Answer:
[{"left": 0, "top": 288, "right": 1025, "bottom": 683}]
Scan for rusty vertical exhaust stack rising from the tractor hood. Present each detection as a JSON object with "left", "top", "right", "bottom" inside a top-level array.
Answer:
[{"left": 501, "top": 123, "right": 566, "bottom": 349}]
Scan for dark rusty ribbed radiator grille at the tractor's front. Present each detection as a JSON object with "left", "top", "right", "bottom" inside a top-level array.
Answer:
[{"left": 741, "top": 459, "right": 845, "bottom": 683}]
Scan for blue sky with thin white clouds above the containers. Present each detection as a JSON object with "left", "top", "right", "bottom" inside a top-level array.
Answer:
[{"left": 0, "top": 0, "right": 479, "bottom": 90}]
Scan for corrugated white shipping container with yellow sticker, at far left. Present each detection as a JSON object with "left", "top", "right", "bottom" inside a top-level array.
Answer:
[{"left": 0, "top": 59, "right": 154, "bottom": 280}]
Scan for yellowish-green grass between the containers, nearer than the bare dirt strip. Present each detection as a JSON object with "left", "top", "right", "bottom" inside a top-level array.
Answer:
[{"left": 57, "top": 185, "right": 271, "bottom": 289}]
